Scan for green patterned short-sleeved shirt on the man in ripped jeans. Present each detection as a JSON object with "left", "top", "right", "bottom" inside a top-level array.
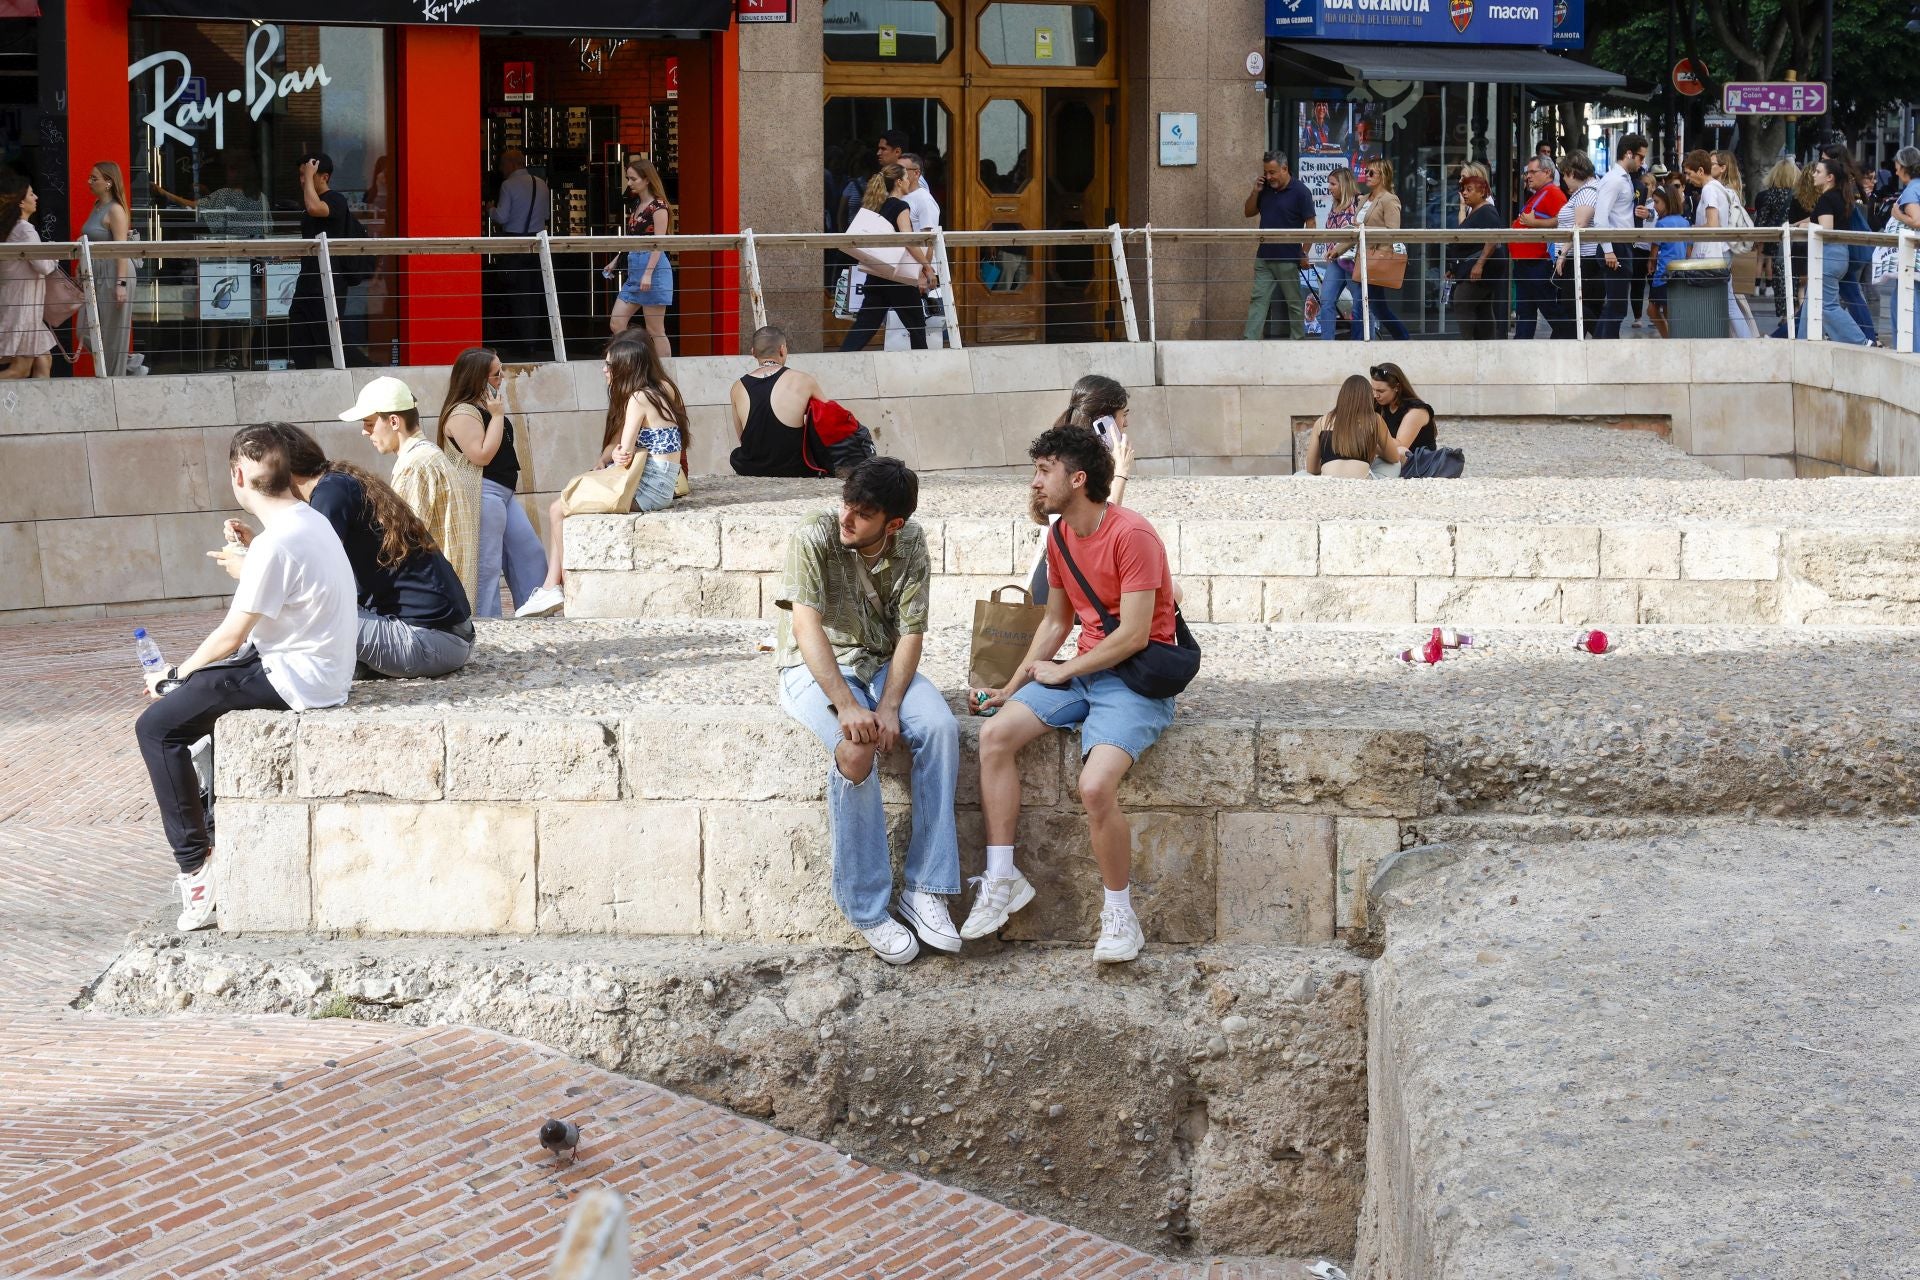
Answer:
[{"left": 774, "top": 510, "right": 933, "bottom": 681}]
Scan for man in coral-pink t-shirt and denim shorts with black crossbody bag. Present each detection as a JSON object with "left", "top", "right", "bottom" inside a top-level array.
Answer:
[{"left": 960, "top": 426, "right": 1175, "bottom": 963}]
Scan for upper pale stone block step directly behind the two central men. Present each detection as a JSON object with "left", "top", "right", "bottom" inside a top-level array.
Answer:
[{"left": 566, "top": 476, "right": 1920, "bottom": 626}]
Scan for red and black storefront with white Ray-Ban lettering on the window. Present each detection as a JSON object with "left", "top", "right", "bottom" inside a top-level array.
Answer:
[{"left": 33, "top": 0, "right": 737, "bottom": 372}]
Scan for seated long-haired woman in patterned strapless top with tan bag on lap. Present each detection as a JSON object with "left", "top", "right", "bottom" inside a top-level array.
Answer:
[{"left": 513, "top": 336, "right": 693, "bottom": 618}]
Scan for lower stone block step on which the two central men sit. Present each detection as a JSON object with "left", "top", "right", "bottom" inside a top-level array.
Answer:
[{"left": 215, "top": 622, "right": 1920, "bottom": 944}]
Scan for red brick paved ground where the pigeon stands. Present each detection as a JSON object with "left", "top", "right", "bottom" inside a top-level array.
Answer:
[{"left": 0, "top": 616, "right": 1302, "bottom": 1280}]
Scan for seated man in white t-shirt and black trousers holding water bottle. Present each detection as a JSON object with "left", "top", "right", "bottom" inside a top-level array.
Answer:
[{"left": 134, "top": 426, "right": 359, "bottom": 931}]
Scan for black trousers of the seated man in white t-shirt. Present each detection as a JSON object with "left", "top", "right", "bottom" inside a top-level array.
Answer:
[{"left": 132, "top": 649, "right": 290, "bottom": 873}]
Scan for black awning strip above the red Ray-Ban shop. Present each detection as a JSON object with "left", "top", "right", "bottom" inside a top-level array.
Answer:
[{"left": 132, "top": 0, "right": 733, "bottom": 35}]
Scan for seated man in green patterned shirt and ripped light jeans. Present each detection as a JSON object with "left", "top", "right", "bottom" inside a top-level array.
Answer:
[{"left": 774, "top": 459, "right": 960, "bottom": 965}]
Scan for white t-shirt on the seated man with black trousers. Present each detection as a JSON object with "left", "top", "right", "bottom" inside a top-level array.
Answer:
[{"left": 232, "top": 503, "right": 359, "bottom": 712}]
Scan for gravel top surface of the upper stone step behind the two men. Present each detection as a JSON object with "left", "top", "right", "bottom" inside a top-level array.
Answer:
[{"left": 675, "top": 475, "right": 1920, "bottom": 528}]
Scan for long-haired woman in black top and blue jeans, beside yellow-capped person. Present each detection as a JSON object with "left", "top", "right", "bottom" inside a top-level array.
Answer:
[{"left": 436, "top": 347, "right": 547, "bottom": 618}]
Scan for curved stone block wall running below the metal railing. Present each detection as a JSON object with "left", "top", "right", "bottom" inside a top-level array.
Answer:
[{"left": 15, "top": 342, "right": 1920, "bottom": 624}]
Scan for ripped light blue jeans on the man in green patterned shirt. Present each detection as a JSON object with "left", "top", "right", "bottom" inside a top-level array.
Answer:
[{"left": 780, "top": 664, "right": 960, "bottom": 929}]
